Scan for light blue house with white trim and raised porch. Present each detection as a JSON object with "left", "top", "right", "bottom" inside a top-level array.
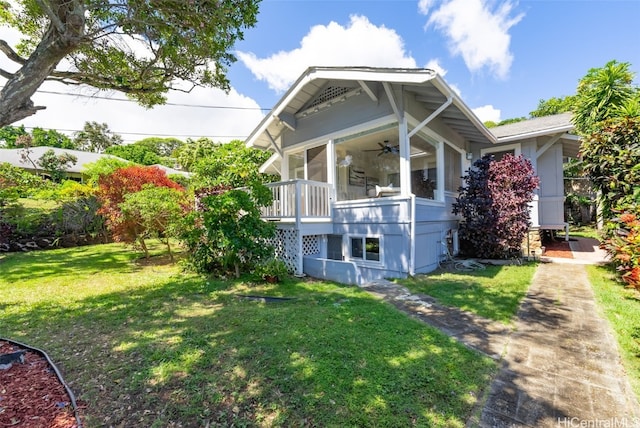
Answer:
[{"left": 246, "top": 67, "right": 575, "bottom": 284}]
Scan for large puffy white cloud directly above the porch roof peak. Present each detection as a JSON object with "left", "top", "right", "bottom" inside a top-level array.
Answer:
[{"left": 237, "top": 15, "right": 416, "bottom": 92}]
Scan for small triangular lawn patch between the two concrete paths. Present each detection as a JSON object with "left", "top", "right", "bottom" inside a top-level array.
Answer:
[{"left": 399, "top": 263, "right": 536, "bottom": 324}]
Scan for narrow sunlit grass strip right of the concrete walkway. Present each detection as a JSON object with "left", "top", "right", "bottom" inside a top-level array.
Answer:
[{"left": 587, "top": 266, "right": 640, "bottom": 399}]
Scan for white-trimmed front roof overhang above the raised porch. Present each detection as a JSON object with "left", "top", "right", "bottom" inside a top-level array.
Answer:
[{"left": 246, "top": 67, "right": 494, "bottom": 152}]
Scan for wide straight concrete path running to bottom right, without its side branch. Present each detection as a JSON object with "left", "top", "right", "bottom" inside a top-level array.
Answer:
[{"left": 476, "top": 263, "right": 640, "bottom": 428}]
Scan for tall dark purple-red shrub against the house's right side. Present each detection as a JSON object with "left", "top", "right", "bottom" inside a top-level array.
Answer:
[{"left": 453, "top": 154, "right": 539, "bottom": 258}]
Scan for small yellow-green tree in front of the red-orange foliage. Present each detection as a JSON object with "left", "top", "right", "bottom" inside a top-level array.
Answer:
[{"left": 119, "top": 185, "right": 187, "bottom": 262}]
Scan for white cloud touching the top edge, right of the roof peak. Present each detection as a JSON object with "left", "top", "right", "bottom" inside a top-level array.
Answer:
[{"left": 418, "top": 0, "right": 524, "bottom": 78}]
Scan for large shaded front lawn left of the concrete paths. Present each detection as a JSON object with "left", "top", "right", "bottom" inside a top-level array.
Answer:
[{"left": 0, "top": 244, "right": 496, "bottom": 427}]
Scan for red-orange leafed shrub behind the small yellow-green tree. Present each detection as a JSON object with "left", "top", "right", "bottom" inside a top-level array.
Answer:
[{"left": 97, "top": 165, "right": 182, "bottom": 254}]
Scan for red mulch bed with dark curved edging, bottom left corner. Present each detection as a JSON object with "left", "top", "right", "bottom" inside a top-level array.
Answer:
[{"left": 0, "top": 341, "right": 78, "bottom": 428}]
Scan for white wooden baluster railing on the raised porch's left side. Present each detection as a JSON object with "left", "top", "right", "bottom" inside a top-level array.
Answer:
[{"left": 262, "top": 180, "right": 333, "bottom": 223}]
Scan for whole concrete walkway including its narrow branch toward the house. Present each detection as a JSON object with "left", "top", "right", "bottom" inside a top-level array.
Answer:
[{"left": 364, "top": 239, "right": 640, "bottom": 428}]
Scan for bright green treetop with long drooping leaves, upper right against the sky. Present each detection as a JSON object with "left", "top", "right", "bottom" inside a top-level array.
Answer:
[{"left": 573, "top": 60, "right": 640, "bottom": 135}]
